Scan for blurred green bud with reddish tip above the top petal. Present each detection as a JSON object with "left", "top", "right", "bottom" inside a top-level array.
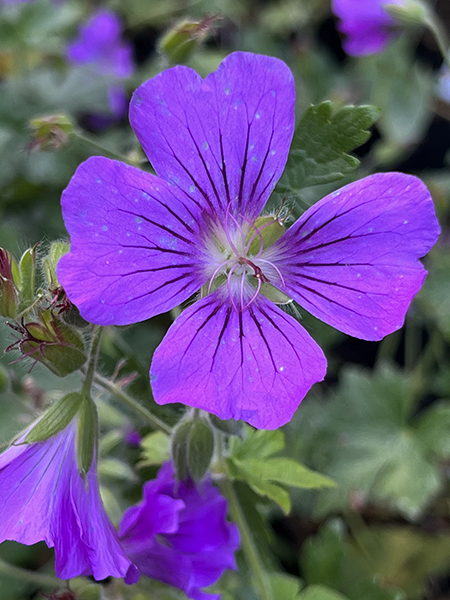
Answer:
[{"left": 158, "top": 16, "right": 218, "bottom": 65}]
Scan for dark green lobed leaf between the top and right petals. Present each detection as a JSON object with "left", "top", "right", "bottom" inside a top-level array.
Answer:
[{"left": 276, "top": 101, "right": 380, "bottom": 193}]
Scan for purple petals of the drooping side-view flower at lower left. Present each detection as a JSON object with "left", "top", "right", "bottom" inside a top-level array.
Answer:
[{"left": 0, "top": 420, "right": 138, "bottom": 583}]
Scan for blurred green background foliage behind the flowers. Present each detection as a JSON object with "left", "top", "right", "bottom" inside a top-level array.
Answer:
[{"left": 0, "top": 0, "right": 450, "bottom": 600}]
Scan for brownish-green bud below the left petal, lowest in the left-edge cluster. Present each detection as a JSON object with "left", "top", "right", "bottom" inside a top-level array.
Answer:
[{"left": 6, "top": 310, "right": 86, "bottom": 377}]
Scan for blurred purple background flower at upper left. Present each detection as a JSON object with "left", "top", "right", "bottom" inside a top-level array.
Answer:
[{"left": 66, "top": 9, "right": 134, "bottom": 119}]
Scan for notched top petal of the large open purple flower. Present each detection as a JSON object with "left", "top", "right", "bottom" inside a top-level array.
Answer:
[{"left": 130, "top": 52, "right": 295, "bottom": 217}]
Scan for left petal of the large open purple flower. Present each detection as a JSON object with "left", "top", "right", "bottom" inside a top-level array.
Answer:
[{"left": 58, "top": 157, "right": 205, "bottom": 325}]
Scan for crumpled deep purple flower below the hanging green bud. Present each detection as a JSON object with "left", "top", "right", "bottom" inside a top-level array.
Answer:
[{"left": 119, "top": 463, "right": 239, "bottom": 600}]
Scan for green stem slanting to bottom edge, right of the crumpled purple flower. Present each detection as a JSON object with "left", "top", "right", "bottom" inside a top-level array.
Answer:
[{"left": 220, "top": 477, "right": 273, "bottom": 600}]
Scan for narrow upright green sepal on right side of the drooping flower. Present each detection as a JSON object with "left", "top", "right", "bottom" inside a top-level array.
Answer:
[{"left": 76, "top": 394, "right": 98, "bottom": 478}]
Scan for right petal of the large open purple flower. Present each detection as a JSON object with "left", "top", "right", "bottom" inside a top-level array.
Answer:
[{"left": 272, "top": 173, "right": 440, "bottom": 340}]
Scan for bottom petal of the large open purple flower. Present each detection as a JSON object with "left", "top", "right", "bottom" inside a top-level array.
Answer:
[{"left": 150, "top": 290, "right": 326, "bottom": 429}]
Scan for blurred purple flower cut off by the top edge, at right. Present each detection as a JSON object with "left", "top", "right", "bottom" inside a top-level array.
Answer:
[{"left": 332, "top": 0, "right": 403, "bottom": 56}]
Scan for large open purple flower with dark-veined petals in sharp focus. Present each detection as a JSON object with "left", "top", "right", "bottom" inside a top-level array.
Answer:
[{"left": 58, "top": 52, "right": 439, "bottom": 429}]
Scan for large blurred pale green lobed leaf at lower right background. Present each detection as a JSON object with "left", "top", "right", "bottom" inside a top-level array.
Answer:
[{"left": 288, "top": 366, "right": 449, "bottom": 518}]
